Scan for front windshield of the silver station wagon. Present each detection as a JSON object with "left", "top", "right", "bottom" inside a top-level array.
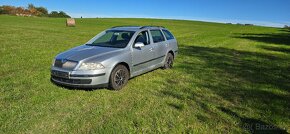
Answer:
[{"left": 87, "top": 30, "right": 135, "bottom": 48}]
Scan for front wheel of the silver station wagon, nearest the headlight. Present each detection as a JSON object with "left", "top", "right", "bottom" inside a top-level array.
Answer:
[{"left": 109, "top": 65, "right": 129, "bottom": 90}]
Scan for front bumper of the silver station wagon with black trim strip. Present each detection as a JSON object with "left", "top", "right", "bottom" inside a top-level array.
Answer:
[{"left": 51, "top": 67, "right": 110, "bottom": 88}]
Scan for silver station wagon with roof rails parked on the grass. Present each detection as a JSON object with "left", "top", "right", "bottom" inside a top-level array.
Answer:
[{"left": 51, "top": 26, "right": 178, "bottom": 90}]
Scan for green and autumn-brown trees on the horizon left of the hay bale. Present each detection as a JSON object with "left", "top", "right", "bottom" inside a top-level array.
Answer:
[{"left": 0, "top": 4, "right": 71, "bottom": 18}]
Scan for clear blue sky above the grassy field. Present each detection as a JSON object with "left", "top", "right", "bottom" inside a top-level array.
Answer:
[{"left": 0, "top": 0, "right": 290, "bottom": 27}]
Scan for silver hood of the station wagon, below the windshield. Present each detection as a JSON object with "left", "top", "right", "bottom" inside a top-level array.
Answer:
[{"left": 56, "top": 45, "right": 120, "bottom": 61}]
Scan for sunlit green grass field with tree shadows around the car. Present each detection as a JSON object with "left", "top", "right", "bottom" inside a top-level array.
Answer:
[{"left": 0, "top": 15, "right": 290, "bottom": 133}]
